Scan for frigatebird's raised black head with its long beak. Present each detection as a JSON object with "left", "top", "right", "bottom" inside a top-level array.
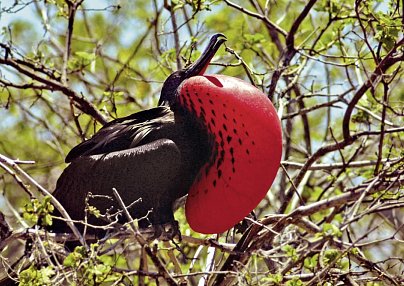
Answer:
[{"left": 158, "top": 34, "right": 227, "bottom": 106}]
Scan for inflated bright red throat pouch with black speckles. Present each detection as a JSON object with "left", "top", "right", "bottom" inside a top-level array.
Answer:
[{"left": 179, "top": 75, "right": 282, "bottom": 234}]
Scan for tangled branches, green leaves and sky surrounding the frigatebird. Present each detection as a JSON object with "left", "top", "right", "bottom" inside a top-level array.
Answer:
[{"left": 0, "top": 0, "right": 404, "bottom": 285}]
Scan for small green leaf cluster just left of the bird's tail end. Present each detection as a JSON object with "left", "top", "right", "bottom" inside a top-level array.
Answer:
[{"left": 23, "top": 197, "right": 54, "bottom": 226}]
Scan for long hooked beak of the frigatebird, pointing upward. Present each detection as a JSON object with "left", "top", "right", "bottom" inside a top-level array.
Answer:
[{"left": 184, "top": 33, "right": 227, "bottom": 78}]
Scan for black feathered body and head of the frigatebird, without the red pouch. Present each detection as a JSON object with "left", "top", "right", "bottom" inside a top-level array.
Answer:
[{"left": 52, "top": 34, "right": 226, "bottom": 238}]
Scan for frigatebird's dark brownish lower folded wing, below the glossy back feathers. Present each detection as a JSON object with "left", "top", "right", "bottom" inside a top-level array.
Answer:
[{"left": 52, "top": 139, "right": 182, "bottom": 233}]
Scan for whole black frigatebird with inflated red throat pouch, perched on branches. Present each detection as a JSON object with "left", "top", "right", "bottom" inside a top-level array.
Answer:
[{"left": 53, "top": 34, "right": 282, "bottom": 238}]
